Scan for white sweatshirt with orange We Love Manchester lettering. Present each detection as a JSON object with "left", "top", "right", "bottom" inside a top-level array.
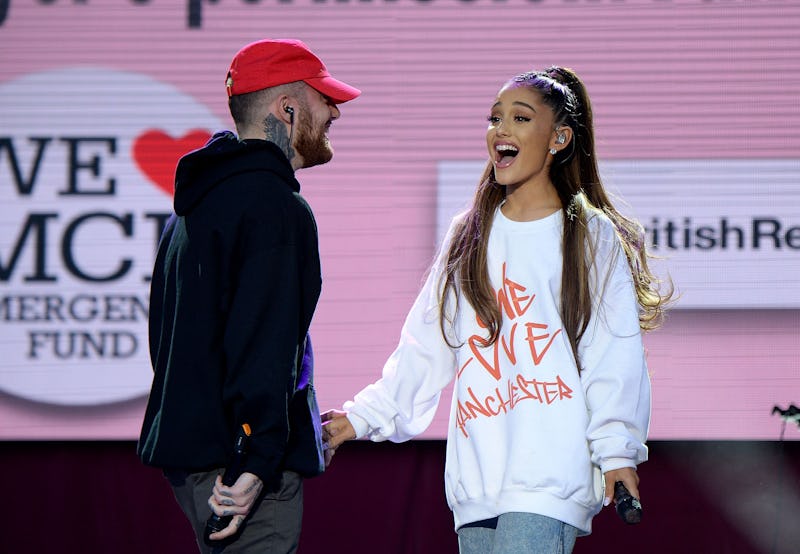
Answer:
[{"left": 345, "top": 205, "right": 650, "bottom": 534}]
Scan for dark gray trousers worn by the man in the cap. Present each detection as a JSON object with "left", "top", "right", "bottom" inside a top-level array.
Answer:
[{"left": 167, "top": 470, "right": 303, "bottom": 554}]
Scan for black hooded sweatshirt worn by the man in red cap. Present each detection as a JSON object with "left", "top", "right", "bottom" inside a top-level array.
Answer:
[{"left": 138, "top": 131, "right": 324, "bottom": 486}]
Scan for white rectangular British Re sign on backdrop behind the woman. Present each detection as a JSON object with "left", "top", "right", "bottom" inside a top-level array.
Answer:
[{"left": 437, "top": 159, "right": 800, "bottom": 309}]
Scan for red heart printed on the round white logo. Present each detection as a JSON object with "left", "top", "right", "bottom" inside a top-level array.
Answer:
[{"left": 133, "top": 129, "right": 211, "bottom": 196}]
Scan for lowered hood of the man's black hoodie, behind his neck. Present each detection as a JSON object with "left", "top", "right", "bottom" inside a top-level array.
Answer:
[{"left": 174, "top": 131, "right": 300, "bottom": 216}]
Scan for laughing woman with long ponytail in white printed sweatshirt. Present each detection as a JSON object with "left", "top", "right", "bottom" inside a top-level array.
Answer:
[{"left": 323, "top": 67, "right": 671, "bottom": 554}]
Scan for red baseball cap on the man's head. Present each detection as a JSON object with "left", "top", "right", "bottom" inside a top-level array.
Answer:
[{"left": 225, "top": 39, "right": 361, "bottom": 104}]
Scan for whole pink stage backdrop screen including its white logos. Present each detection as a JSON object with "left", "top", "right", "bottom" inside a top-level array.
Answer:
[{"left": 0, "top": 0, "right": 800, "bottom": 439}]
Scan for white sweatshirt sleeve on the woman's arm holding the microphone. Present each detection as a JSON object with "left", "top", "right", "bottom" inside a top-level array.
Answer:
[{"left": 579, "top": 216, "right": 650, "bottom": 473}]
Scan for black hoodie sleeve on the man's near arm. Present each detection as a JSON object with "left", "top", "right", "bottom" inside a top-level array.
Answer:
[{"left": 223, "top": 196, "right": 303, "bottom": 484}]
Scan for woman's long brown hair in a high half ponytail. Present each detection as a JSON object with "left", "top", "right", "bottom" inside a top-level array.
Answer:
[{"left": 439, "top": 67, "right": 672, "bottom": 370}]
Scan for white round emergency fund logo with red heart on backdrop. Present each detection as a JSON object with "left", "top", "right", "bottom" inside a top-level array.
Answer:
[{"left": 0, "top": 68, "right": 222, "bottom": 405}]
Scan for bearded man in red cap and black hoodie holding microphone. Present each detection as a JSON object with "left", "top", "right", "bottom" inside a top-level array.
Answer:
[{"left": 138, "top": 36, "right": 360, "bottom": 553}]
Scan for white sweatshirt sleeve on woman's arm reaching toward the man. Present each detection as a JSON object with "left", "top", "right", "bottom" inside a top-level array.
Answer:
[{"left": 344, "top": 220, "right": 456, "bottom": 442}]
